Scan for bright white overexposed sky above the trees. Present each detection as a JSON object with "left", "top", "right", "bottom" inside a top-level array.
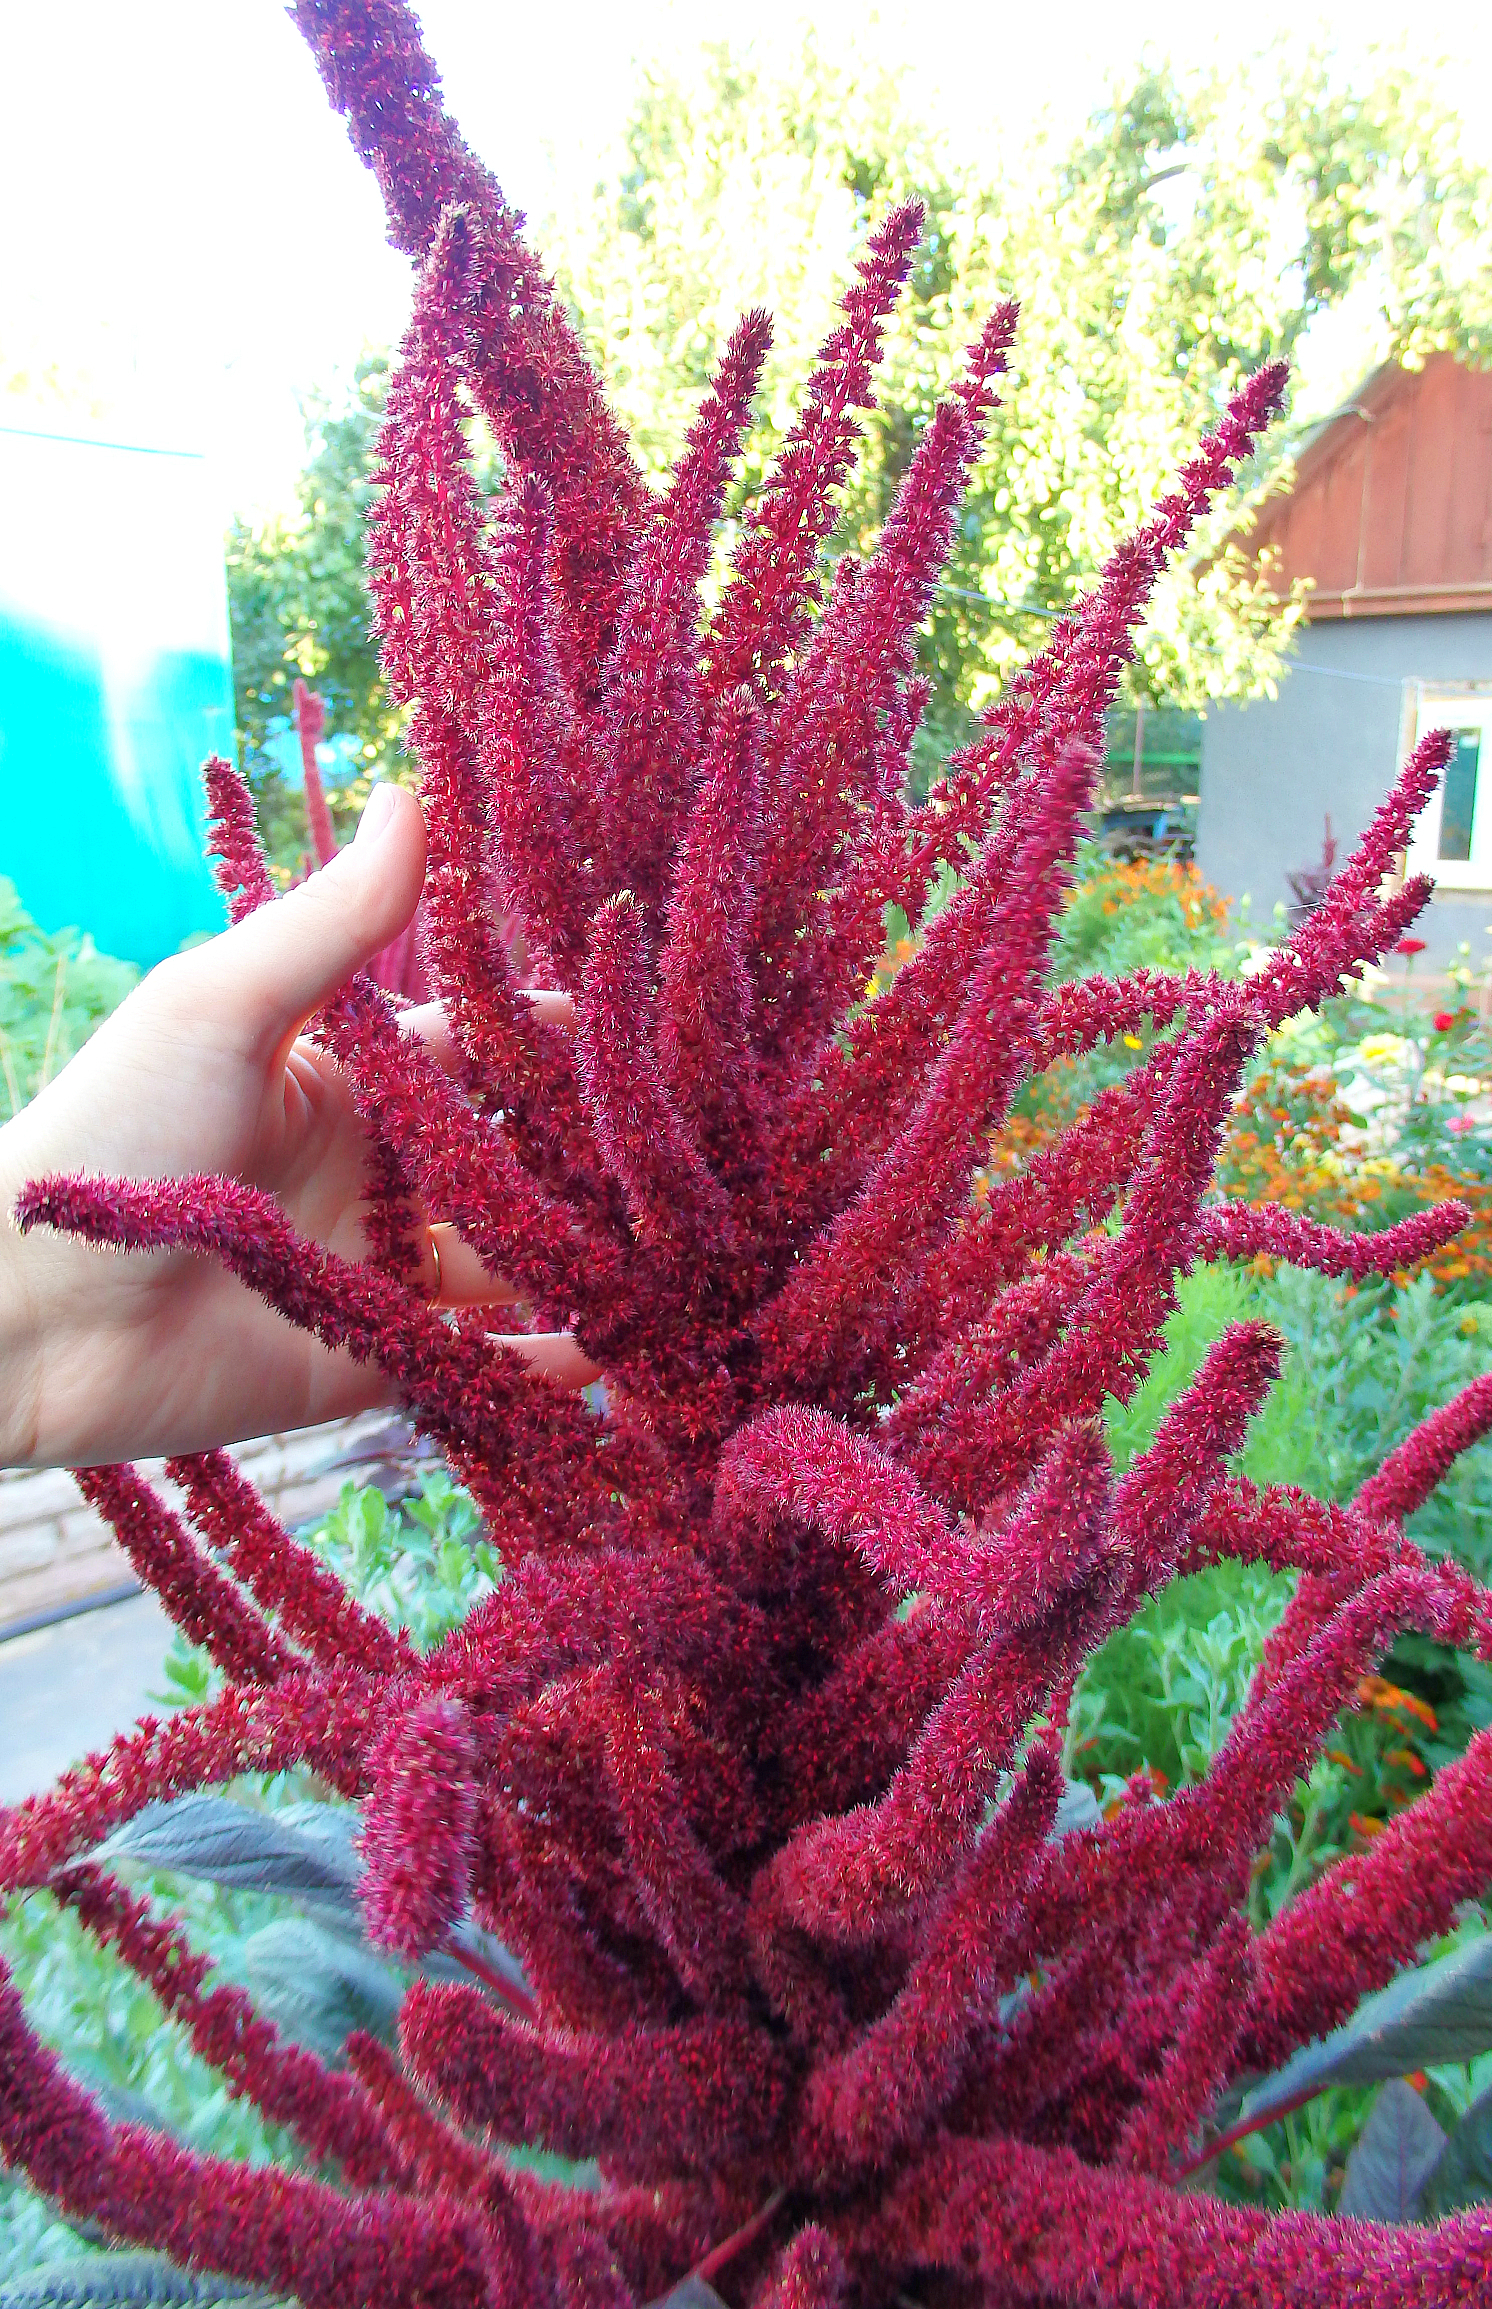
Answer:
[{"left": 0, "top": 0, "right": 1492, "bottom": 513}]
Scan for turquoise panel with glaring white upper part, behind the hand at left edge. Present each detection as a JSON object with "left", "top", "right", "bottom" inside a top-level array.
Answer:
[{"left": 0, "top": 427, "right": 233, "bottom": 965}]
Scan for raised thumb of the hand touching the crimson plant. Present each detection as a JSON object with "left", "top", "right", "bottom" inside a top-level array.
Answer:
[{"left": 201, "top": 785, "right": 425, "bottom": 1037}]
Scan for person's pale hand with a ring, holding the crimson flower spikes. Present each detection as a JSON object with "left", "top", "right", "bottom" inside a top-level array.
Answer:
[{"left": 0, "top": 785, "right": 598, "bottom": 1466}]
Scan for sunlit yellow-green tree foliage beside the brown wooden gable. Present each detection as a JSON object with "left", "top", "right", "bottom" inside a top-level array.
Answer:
[{"left": 559, "top": 46, "right": 1487, "bottom": 757}]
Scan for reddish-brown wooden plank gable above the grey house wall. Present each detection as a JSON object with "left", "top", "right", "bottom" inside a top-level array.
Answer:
[{"left": 1240, "top": 353, "right": 1492, "bottom": 621}]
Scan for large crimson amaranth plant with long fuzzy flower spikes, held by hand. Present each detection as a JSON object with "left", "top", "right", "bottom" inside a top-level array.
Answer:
[{"left": 0, "top": 0, "right": 1492, "bottom": 2309}]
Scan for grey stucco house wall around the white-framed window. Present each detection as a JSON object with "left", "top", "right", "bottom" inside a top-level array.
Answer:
[{"left": 1196, "top": 614, "right": 1492, "bottom": 970}]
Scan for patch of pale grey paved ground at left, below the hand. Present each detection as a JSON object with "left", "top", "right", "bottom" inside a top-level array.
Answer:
[{"left": 0, "top": 1596, "right": 171, "bottom": 1803}]
